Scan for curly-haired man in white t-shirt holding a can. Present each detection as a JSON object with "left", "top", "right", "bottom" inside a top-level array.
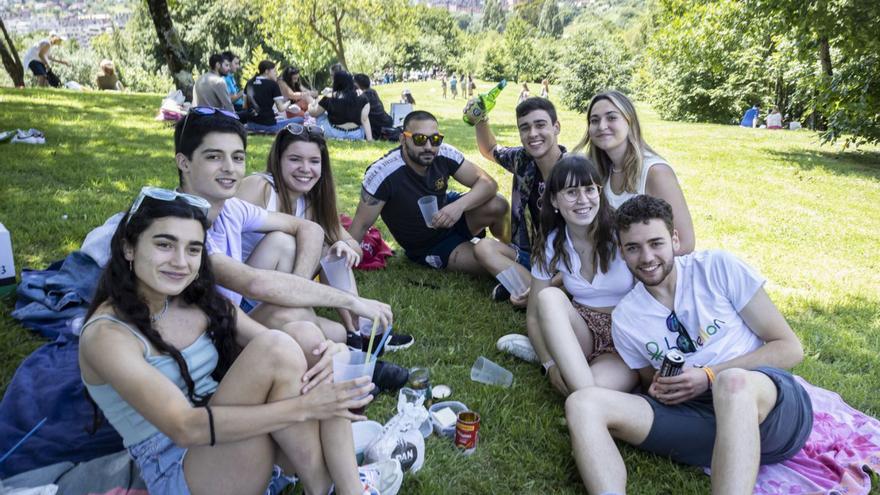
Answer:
[{"left": 565, "top": 195, "right": 813, "bottom": 494}]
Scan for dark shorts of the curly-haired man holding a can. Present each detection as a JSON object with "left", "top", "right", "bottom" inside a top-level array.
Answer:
[{"left": 638, "top": 367, "right": 813, "bottom": 466}]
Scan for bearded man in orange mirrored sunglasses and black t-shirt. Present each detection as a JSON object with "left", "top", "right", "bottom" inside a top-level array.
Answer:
[{"left": 349, "top": 110, "right": 508, "bottom": 274}]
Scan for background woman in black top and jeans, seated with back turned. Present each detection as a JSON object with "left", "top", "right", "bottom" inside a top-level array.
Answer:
[{"left": 309, "top": 70, "right": 373, "bottom": 141}]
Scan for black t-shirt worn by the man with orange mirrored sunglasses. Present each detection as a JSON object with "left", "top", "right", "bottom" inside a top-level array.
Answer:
[{"left": 363, "top": 144, "right": 464, "bottom": 251}]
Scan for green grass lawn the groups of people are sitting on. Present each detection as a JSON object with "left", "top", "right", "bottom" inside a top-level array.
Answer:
[{"left": 0, "top": 82, "right": 880, "bottom": 494}]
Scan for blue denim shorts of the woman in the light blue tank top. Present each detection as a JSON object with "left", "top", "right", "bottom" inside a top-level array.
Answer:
[{"left": 128, "top": 432, "right": 190, "bottom": 495}]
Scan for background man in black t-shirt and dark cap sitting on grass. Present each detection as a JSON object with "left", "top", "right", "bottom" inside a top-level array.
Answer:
[{"left": 245, "top": 60, "right": 303, "bottom": 134}]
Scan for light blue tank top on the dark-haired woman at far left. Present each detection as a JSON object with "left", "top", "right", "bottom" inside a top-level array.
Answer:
[{"left": 80, "top": 315, "right": 219, "bottom": 448}]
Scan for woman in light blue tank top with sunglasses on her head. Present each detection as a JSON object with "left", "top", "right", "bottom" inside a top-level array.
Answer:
[{"left": 79, "top": 189, "right": 403, "bottom": 495}]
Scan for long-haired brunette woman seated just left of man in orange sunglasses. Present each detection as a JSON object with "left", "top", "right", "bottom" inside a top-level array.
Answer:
[{"left": 237, "top": 124, "right": 413, "bottom": 351}]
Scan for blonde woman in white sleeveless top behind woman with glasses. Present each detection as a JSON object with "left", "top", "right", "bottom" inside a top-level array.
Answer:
[{"left": 573, "top": 91, "right": 696, "bottom": 255}]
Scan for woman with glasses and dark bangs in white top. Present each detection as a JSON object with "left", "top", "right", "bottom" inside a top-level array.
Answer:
[{"left": 528, "top": 154, "right": 637, "bottom": 395}]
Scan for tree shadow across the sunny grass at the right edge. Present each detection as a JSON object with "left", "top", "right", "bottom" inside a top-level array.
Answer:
[{"left": 762, "top": 148, "right": 880, "bottom": 179}]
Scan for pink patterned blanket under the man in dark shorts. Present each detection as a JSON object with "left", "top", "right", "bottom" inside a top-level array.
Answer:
[{"left": 755, "top": 376, "right": 880, "bottom": 495}]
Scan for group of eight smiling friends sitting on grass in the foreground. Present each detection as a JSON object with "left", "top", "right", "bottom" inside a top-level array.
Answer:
[{"left": 80, "top": 91, "right": 812, "bottom": 495}]
